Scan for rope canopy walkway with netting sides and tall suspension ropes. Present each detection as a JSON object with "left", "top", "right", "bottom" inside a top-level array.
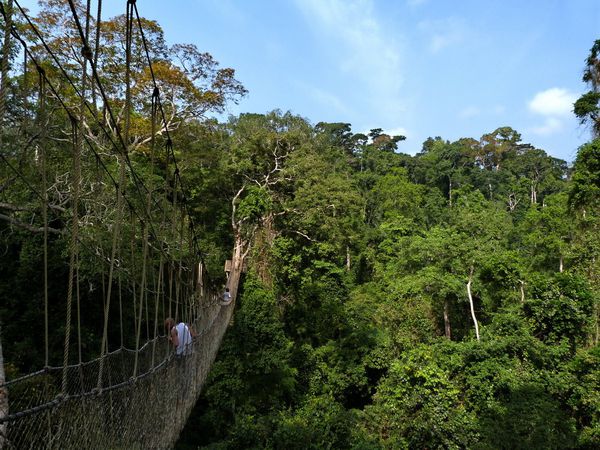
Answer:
[{"left": 0, "top": 0, "right": 243, "bottom": 449}]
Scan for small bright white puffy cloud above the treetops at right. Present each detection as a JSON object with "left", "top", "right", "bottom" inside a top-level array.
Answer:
[{"left": 527, "top": 87, "right": 577, "bottom": 136}]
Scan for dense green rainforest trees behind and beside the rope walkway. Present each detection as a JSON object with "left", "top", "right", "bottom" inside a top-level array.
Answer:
[{"left": 0, "top": 1, "right": 600, "bottom": 449}]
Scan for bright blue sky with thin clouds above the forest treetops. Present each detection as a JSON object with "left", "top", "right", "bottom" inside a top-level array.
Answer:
[{"left": 24, "top": 0, "right": 600, "bottom": 161}]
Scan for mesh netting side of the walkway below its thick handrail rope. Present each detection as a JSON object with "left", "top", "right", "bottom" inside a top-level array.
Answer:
[{"left": 0, "top": 295, "right": 233, "bottom": 449}]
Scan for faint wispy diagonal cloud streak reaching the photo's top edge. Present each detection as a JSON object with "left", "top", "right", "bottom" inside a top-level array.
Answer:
[{"left": 296, "top": 0, "right": 406, "bottom": 117}]
